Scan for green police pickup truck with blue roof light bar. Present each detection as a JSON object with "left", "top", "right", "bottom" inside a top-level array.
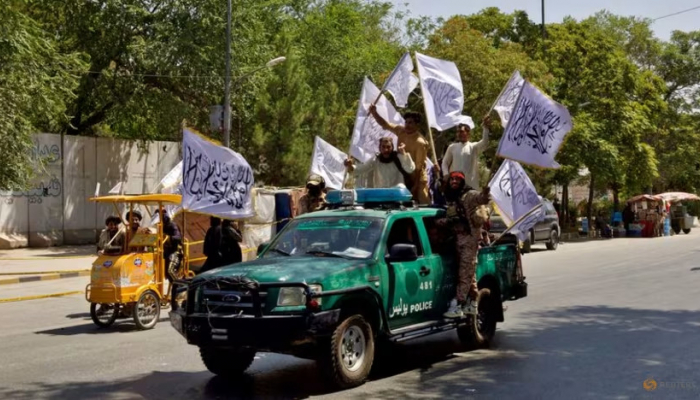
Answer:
[{"left": 170, "top": 188, "right": 527, "bottom": 388}]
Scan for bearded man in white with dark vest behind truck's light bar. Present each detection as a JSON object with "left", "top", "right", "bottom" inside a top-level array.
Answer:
[{"left": 345, "top": 137, "right": 417, "bottom": 188}]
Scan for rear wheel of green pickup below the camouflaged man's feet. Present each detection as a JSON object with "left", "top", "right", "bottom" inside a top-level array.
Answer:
[{"left": 457, "top": 288, "right": 502, "bottom": 349}]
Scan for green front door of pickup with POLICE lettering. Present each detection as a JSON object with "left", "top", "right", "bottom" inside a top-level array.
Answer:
[{"left": 384, "top": 217, "right": 440, "bottom": 329}]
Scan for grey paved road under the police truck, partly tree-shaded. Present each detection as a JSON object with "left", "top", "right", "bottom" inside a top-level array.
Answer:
[{"left": 0, "top": 233, "right": 700, "bottom": 400}]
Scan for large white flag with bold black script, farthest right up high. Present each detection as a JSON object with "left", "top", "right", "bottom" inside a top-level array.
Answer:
[{"left": 496, "top": 82, "right": 573, "bottom": 168}]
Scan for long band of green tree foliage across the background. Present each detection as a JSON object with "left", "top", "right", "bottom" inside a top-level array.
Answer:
[{"left": 0, "top": 0, "right": 700, "bottom": 195}]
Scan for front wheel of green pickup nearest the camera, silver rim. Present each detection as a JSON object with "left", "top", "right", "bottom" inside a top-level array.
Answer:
[{"left": 319, "top": 314, "right": 374, "bottom": 389}]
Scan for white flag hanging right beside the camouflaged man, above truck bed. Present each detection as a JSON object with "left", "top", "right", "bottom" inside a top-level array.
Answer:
[{"left": 489, "top": 160, "right": 542, "bottom": 226}]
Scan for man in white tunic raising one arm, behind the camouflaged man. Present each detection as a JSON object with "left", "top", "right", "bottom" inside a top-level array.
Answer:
[{"left": 442, "top": 116, "right": 491, "bottom": 189}]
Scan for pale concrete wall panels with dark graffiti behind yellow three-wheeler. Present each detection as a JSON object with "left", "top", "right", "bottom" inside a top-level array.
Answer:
[{"left": 0, "top": 133, "right": 181, "bottom": 248}]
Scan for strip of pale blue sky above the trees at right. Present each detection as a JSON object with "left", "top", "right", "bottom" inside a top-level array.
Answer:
[{"left": 391, "top": 0, "right": 700, "bottom": 40}]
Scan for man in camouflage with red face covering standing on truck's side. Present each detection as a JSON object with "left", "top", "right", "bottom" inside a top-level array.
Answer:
[{"left": 439, "top": 171, "right": 490, "bottom": 318}]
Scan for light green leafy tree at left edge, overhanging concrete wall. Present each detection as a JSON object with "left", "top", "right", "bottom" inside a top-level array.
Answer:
[{"left": 0, "top": 1, "right": 86, "bottom": 189}]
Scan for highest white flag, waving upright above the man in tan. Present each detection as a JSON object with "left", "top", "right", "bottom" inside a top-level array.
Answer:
[{"left": 416, "top": 53, "right": 464, "bottom": 131}]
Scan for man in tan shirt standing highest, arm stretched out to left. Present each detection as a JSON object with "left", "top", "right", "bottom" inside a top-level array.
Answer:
[{"left": 369, "top": 105, "right": 430, "bottom": 204}]
